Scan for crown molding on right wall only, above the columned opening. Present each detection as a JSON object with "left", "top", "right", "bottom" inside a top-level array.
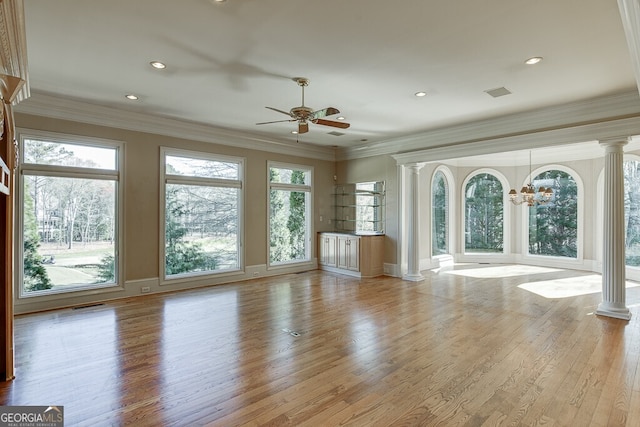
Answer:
[{"left": 337, "top": 91, "right": 640, "bottom": 160}]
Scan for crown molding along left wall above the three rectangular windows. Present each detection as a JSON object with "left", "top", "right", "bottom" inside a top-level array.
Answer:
[{"left": 15, "top": 91, "right": 335, "bottom": 161}]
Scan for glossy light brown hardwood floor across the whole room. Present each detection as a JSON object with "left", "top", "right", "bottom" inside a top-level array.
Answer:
[{"left": 0, "top": 265, "right": 640, "bottom": 426}]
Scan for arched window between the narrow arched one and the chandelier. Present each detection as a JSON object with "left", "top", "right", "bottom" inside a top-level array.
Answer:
[{"left": 464, "top": 173, "right": 504, "bottom": 253}]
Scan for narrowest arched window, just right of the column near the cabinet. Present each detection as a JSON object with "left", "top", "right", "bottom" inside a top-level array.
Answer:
[{"left": 431, "top": 171, "right": 449, "bottom": 256}]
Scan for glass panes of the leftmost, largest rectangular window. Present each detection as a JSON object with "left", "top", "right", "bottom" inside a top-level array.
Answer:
[{"left": 17, "top": 134, "right": 122, "bottom": 296}]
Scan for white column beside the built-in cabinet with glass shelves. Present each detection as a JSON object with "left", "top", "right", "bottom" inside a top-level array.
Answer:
[{"left": 402, "top": 163, "right": 424, "bottom": 282}]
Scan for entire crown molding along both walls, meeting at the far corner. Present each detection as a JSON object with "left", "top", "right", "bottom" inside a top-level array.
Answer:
[{"left": 15, "top": 91, "right": 640, "bottom": 164}]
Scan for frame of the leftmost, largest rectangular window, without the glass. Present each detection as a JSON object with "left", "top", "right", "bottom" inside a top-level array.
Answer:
[{"left": 14, "top": 128, "right": 125, "bottom": 302}]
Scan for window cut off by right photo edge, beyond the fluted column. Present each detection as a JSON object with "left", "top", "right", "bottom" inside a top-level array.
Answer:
[{"left": 624, "top": 159, "right": 640, "bottom": 267}]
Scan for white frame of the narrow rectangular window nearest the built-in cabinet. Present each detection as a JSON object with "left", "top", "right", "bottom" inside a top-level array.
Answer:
[{"left": 266, "top": 160, "right": 314, "bottom": 270}]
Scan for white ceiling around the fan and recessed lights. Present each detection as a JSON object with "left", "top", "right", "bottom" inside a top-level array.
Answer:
[{"left": 20, "top": 0, "right": 636, "bottom": 151}]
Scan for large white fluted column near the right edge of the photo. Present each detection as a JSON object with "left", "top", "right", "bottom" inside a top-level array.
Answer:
[{"left": 596, "top": 140, "right": 631, "bottom": 320}]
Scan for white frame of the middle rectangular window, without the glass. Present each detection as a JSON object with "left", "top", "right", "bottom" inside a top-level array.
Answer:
[{"left": 158, "top": 147, "right": 246, "bottom": 286}]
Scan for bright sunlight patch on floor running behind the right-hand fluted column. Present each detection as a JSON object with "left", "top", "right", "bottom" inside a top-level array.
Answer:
[{"left": 518, "top": 274, "right": 640, "bottom": 299}]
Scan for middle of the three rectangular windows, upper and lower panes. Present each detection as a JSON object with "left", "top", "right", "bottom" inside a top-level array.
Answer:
[{"left": 162, "top": 149, "right": 243, "bottom": 279}]
